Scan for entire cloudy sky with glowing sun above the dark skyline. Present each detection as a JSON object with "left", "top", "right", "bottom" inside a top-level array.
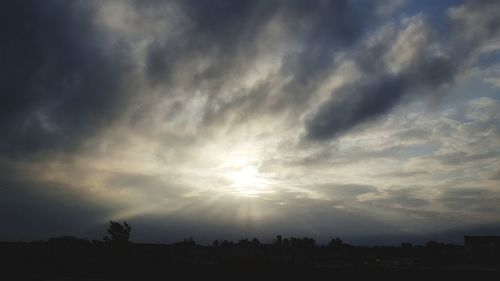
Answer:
[{"left": 0, "top": 0, "right": 500, "bottom": 243}]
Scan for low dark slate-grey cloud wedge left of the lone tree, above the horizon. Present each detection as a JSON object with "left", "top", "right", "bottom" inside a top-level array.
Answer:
[{"left": 0, "top": 163, "right": 118, "bottom": 241}]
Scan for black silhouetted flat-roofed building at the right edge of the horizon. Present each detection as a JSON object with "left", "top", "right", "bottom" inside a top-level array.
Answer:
[{"left": 464, "top": 236, "right": 500, "bottom": 266}]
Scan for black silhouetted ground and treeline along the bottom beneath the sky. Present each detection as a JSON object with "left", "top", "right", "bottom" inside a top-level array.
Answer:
[{"left": 0, "top": 236, "right": 500, "bottom": 280}]
